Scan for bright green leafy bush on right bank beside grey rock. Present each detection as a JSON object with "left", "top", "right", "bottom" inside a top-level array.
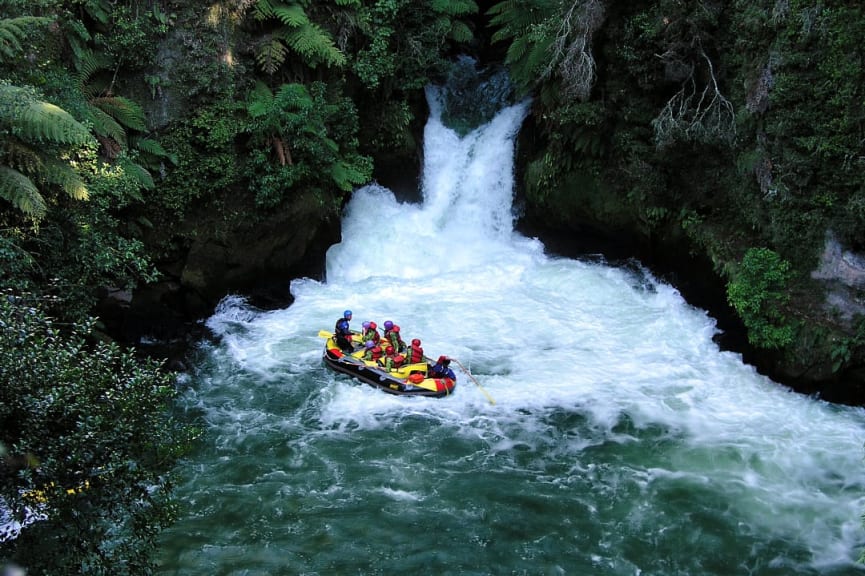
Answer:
[{"left": 727, "top": 248, "right": 793, "bottom": 348}]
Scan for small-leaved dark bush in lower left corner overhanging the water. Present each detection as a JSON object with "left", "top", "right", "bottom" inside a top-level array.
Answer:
[{"left": 0, "top": 292, "right": 192, "bottom": 575}]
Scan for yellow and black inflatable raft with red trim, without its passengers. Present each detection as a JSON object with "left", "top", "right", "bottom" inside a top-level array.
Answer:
[{"left": 324, "top": 336, "right": 456, "bottom": 398}]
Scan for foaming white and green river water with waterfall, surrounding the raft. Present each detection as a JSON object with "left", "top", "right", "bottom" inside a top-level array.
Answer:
[{"left": 158, "top": 74, "right": 865, "bottom": 576}]
